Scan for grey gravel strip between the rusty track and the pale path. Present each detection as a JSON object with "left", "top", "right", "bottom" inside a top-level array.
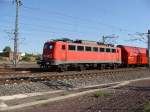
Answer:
[{"left": 0, "top": 68, "right": 150, "bottom": 96}]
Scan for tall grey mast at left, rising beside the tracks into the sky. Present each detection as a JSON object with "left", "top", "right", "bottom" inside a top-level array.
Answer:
[{"left": 13, "top": 0, "right": 21, "bottom": 67}]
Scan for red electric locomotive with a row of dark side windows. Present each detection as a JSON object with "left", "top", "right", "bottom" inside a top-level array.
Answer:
[{"left": 40, "top": 41, "right": 121, "bottom": 69}]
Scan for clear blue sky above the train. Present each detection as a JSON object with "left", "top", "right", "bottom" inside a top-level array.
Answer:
[{"left": 0, "top": 0, "right": 150, "bottom": 53}]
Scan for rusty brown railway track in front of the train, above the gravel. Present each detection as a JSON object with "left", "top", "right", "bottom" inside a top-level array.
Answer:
[{"left": 0, "top": 68, "right": 150, "bottom": 84}]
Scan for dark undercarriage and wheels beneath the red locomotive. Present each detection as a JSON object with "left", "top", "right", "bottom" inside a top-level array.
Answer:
[{"left": 38, "top": 60, "right": 121, "bottom": 72}]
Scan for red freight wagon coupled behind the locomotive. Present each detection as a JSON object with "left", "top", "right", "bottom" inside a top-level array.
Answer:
[{"left": 118, "top": 45, "right": 148, "bottom": 66}]
